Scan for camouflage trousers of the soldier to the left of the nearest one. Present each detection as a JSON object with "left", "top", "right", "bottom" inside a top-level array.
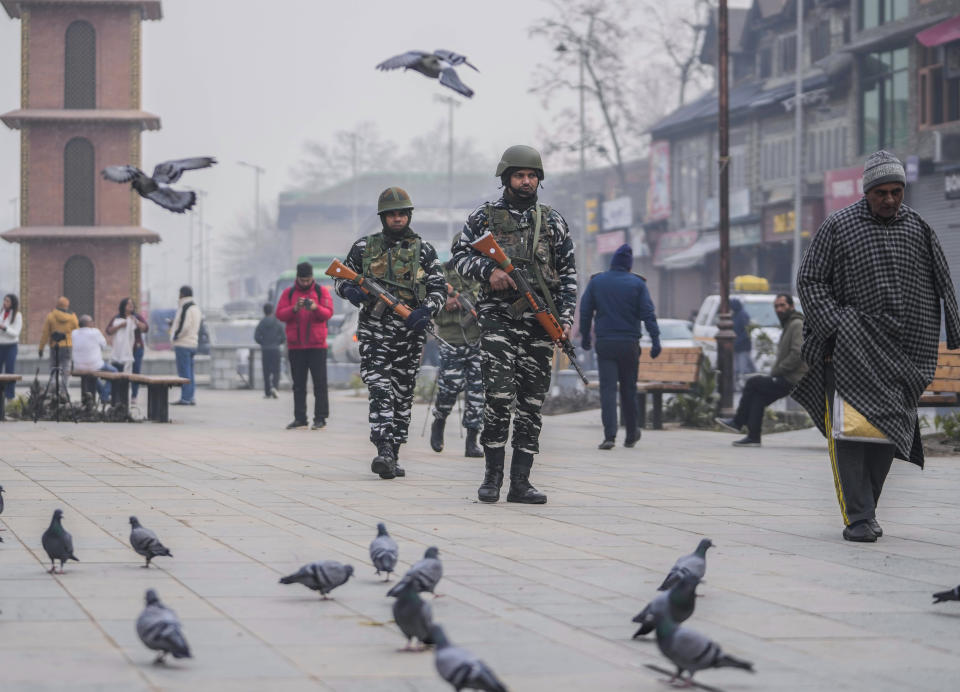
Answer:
[{"left": 357, "top": 314, "right": 426, "bottom": 444}]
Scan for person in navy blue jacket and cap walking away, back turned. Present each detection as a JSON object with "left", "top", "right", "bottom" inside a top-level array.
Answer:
[{"left": 580, "top": 244, "right": 660, "bottom": 449}]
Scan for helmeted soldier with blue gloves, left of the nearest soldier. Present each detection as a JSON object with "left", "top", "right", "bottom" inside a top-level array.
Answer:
[{"left": 336, "top": 187, "right": 447, "bottom": 478}]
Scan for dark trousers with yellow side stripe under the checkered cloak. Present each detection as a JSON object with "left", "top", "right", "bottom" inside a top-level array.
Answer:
[{"left": 823, "top": 364, "right": 894, "bottom": 526}]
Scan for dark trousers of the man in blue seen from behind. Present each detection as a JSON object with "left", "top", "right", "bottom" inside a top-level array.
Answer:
[{"left": 597, "top": 339, "right": 640, "bottom": 440}]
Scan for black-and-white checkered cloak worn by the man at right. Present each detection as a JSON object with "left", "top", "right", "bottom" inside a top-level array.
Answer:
[{"left": 793, "top": 198, "right": 960, "bottom": 468}]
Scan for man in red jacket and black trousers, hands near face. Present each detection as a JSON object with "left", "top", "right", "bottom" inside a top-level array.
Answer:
[{"left": 276, "top": 262, "right": 333, "bottom": 430}]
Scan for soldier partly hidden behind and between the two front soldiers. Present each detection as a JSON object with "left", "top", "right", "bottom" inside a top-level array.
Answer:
[{"left": 430, "top": 240, "right": 483, "bottom": 457}]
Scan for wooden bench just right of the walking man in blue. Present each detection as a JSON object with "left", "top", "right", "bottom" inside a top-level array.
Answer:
[{"left": 637, "top": 346, "right": 703, "bottom": 430}]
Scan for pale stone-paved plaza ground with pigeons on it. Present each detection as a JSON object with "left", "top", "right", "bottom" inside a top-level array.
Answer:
[{"left": 0, "top": 389, "right": 960, "bottom": 692}]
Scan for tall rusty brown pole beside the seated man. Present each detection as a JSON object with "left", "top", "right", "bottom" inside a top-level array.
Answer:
[{"left": 716, "top": 0, "right": 735, "bottom": 416}]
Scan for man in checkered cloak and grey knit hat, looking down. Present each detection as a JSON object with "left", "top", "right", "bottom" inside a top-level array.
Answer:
[{"left": 793, "top": 151, "right": 960, "bottom": 542}]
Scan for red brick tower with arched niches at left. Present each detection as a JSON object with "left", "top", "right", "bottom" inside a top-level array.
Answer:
[{"left": 0, "top": 0, "right": 162, "bottom": 344}]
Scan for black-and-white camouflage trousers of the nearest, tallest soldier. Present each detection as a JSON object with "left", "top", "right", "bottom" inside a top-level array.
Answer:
[{"left": 480, "top": 308, "right": 553, "bottom": 454}]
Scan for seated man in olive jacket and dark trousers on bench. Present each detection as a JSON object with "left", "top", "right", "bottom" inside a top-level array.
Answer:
[{"left": 714, "top": 293, "right": 807, "bottom": 447}]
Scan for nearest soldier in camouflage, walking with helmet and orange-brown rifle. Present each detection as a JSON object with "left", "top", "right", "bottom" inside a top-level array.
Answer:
[{"left": 453, "top": 146, "right": 577, "bottom": 504}]
